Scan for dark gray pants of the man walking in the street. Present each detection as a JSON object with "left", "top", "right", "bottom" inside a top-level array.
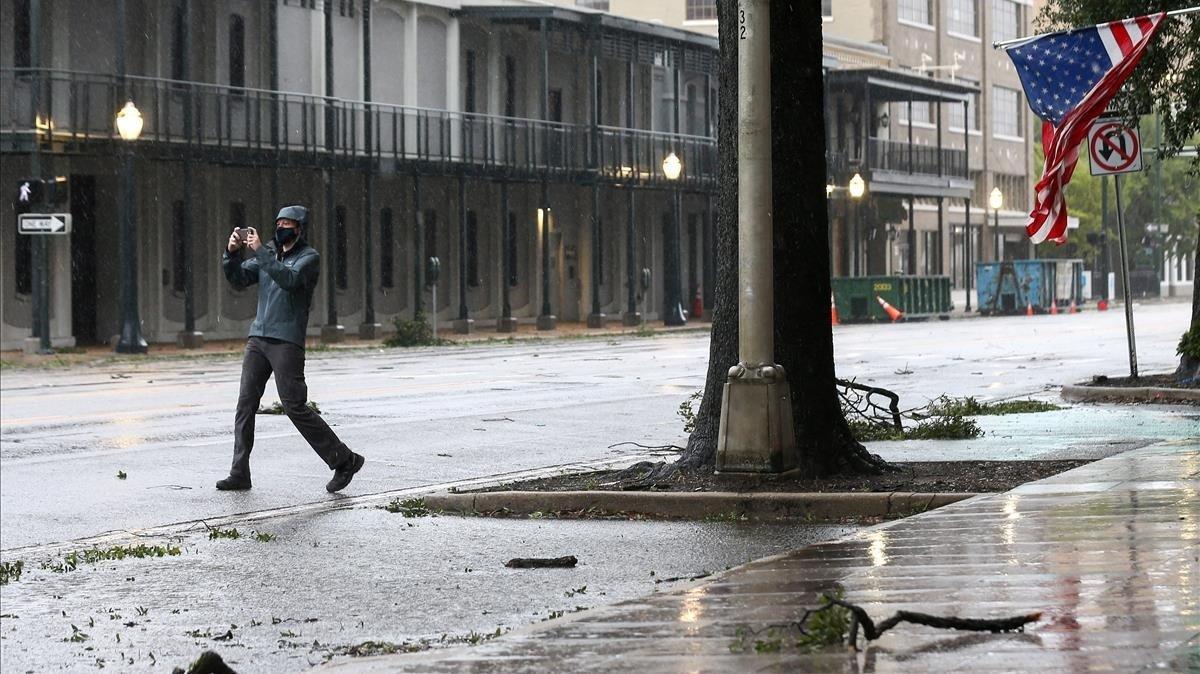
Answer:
[{"left": 229, "top": 337, "right": 352, "bottom": 477}]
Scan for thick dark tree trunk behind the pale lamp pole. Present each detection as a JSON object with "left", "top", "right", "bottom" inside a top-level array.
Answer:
[{"left": 678, "top": 0, "right": 887, "bottom": 476}]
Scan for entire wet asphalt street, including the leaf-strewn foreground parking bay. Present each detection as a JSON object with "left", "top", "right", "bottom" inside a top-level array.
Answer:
[{"left": 0, "top": 303, "right": 1194, "bottom": 672}]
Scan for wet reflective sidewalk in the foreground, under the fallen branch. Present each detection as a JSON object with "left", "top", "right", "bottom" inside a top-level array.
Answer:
[{"left": 324, "top": 438, "right": 1200, "bottom": 674}]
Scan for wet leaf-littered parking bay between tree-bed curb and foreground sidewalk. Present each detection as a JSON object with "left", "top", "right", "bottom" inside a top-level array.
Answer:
[{"left": 0, "top": 507, "right": 854, "bottom": 674}]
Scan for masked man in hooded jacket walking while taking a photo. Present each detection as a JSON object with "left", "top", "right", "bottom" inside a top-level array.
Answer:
[{"left": 217, "top": 201, "right": 365, "bottom": 492}]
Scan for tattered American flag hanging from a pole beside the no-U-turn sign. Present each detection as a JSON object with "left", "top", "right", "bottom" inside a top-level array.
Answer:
[{"left": 1006, "top": 12, "right": 1165, "bottom": 243}]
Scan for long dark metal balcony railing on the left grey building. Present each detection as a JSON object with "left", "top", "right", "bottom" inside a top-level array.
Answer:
[{"left": 0, "top": 68, "right": 716, "bottom": 182}]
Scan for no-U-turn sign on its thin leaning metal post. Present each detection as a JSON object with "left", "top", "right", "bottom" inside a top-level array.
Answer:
[{"left": 1087, "top": 119, "right": 1141, "bottom": 379}]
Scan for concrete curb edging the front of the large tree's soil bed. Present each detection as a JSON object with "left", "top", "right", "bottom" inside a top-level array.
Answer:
[{"left": 425, "top": 492, "right": 977, "bottom": 519}]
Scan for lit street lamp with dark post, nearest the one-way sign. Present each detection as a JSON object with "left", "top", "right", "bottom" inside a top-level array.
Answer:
[{"left": 116, "top": 101, "right": 148, "bottom": 354}]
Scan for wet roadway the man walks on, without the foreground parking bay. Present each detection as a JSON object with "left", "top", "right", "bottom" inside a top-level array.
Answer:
[{"left": 0, "top": 303, "right": 1189, "bottom": 550}]
